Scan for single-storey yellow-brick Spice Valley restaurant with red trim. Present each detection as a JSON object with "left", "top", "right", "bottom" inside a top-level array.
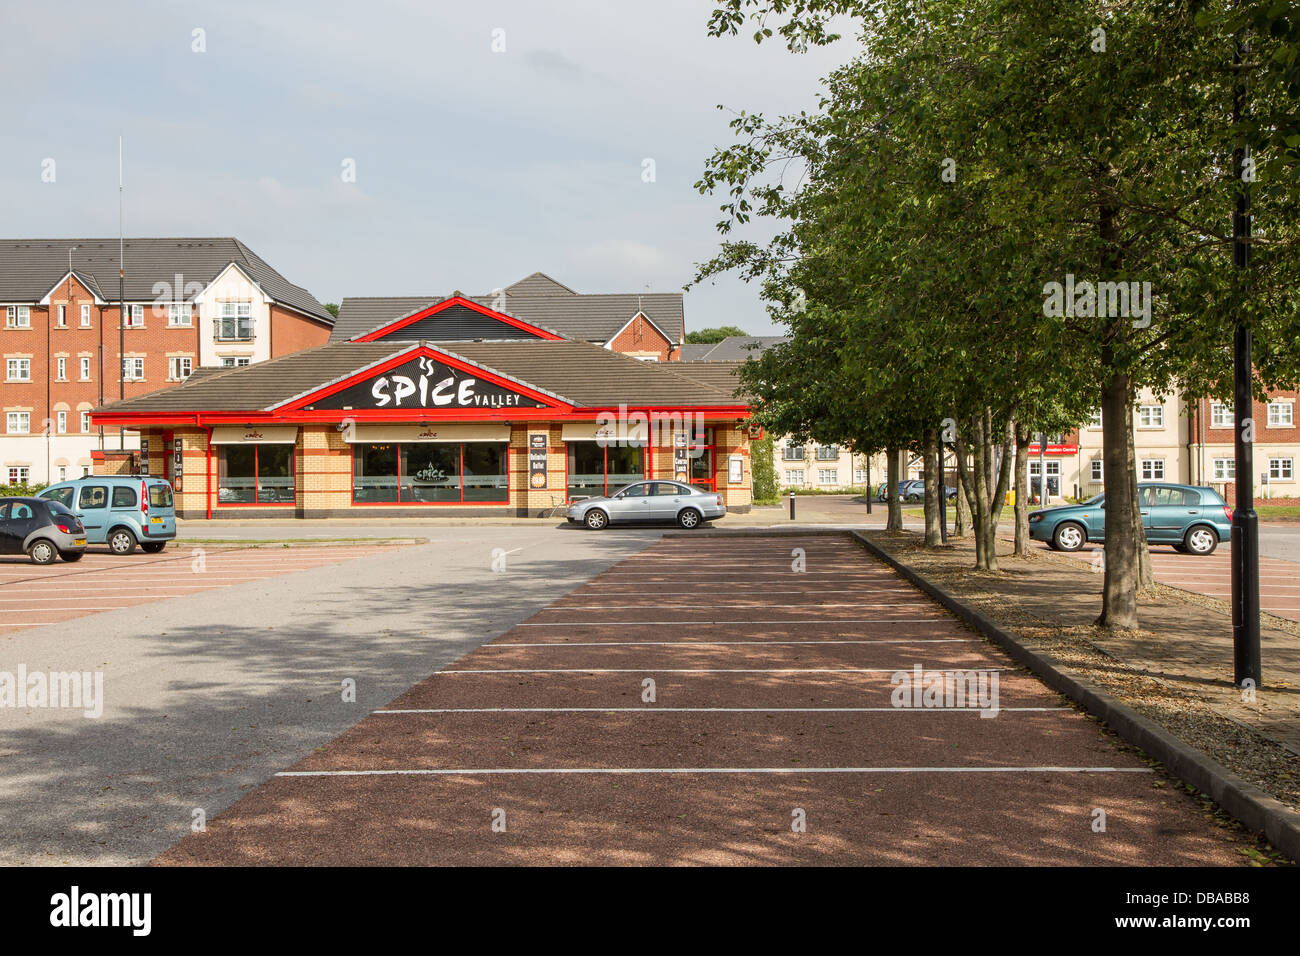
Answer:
[{"left": 92, "top": 294, "right": 751, "bottom": 518}]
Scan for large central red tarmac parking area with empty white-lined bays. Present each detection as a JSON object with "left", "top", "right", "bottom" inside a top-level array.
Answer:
[{"left": 156, "top": 536, "right": 1245, "bottom": 866}]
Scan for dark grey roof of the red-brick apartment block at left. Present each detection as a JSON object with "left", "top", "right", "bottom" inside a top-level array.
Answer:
[{"left": 0, "top": 237, "right": 334, "bottom": 325}]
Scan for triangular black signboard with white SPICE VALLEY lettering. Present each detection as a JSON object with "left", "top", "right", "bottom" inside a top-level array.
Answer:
[{"left": 313, "top": 355, "right": 546, "bottom": 408}]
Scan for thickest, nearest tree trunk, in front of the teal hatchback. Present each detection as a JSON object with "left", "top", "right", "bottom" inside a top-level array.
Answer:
[{"left": 1097, "top": 369, "right": 1141, "bottom": 628}]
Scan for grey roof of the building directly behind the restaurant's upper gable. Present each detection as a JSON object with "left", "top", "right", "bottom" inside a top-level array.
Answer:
[{"left": 330, "top": 272, "right": 685, "bottom": 343}]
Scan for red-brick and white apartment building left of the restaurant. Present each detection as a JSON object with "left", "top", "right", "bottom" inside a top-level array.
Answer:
[{"left": 0, "top": 238, "right": 334, "bottom": 484}]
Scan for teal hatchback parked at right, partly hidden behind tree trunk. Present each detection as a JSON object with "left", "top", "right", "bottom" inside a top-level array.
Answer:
[{"left": 1030, "top": 483, "right": 1232, "bottom": 554}]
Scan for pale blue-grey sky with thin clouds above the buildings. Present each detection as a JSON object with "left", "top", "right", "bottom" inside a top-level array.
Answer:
[{"left": 0, "top": 0, "right": 855, "bottom": 334}]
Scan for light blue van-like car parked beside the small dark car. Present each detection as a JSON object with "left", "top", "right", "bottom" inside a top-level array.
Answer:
[{"left": 40, "top": 475, "right": 176, "bottom": 554}]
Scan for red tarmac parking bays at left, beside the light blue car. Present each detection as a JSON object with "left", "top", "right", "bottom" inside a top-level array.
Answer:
[{"left": 0, "top": 542, "right": 395, "bottom": 635}]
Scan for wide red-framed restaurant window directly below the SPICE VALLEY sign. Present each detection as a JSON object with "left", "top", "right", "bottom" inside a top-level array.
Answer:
[{"left": 352, "top": 442, "right": 510, "bottom": 505}]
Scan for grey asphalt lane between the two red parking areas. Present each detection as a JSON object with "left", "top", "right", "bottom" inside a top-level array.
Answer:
[{"left": 0, "top": 523, "right": 663, "bottom": 865}]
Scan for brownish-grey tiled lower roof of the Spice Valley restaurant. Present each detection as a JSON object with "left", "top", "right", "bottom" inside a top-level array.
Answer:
[{"left": 98, "top": 338, "right": 742, "bottom": 414}]
